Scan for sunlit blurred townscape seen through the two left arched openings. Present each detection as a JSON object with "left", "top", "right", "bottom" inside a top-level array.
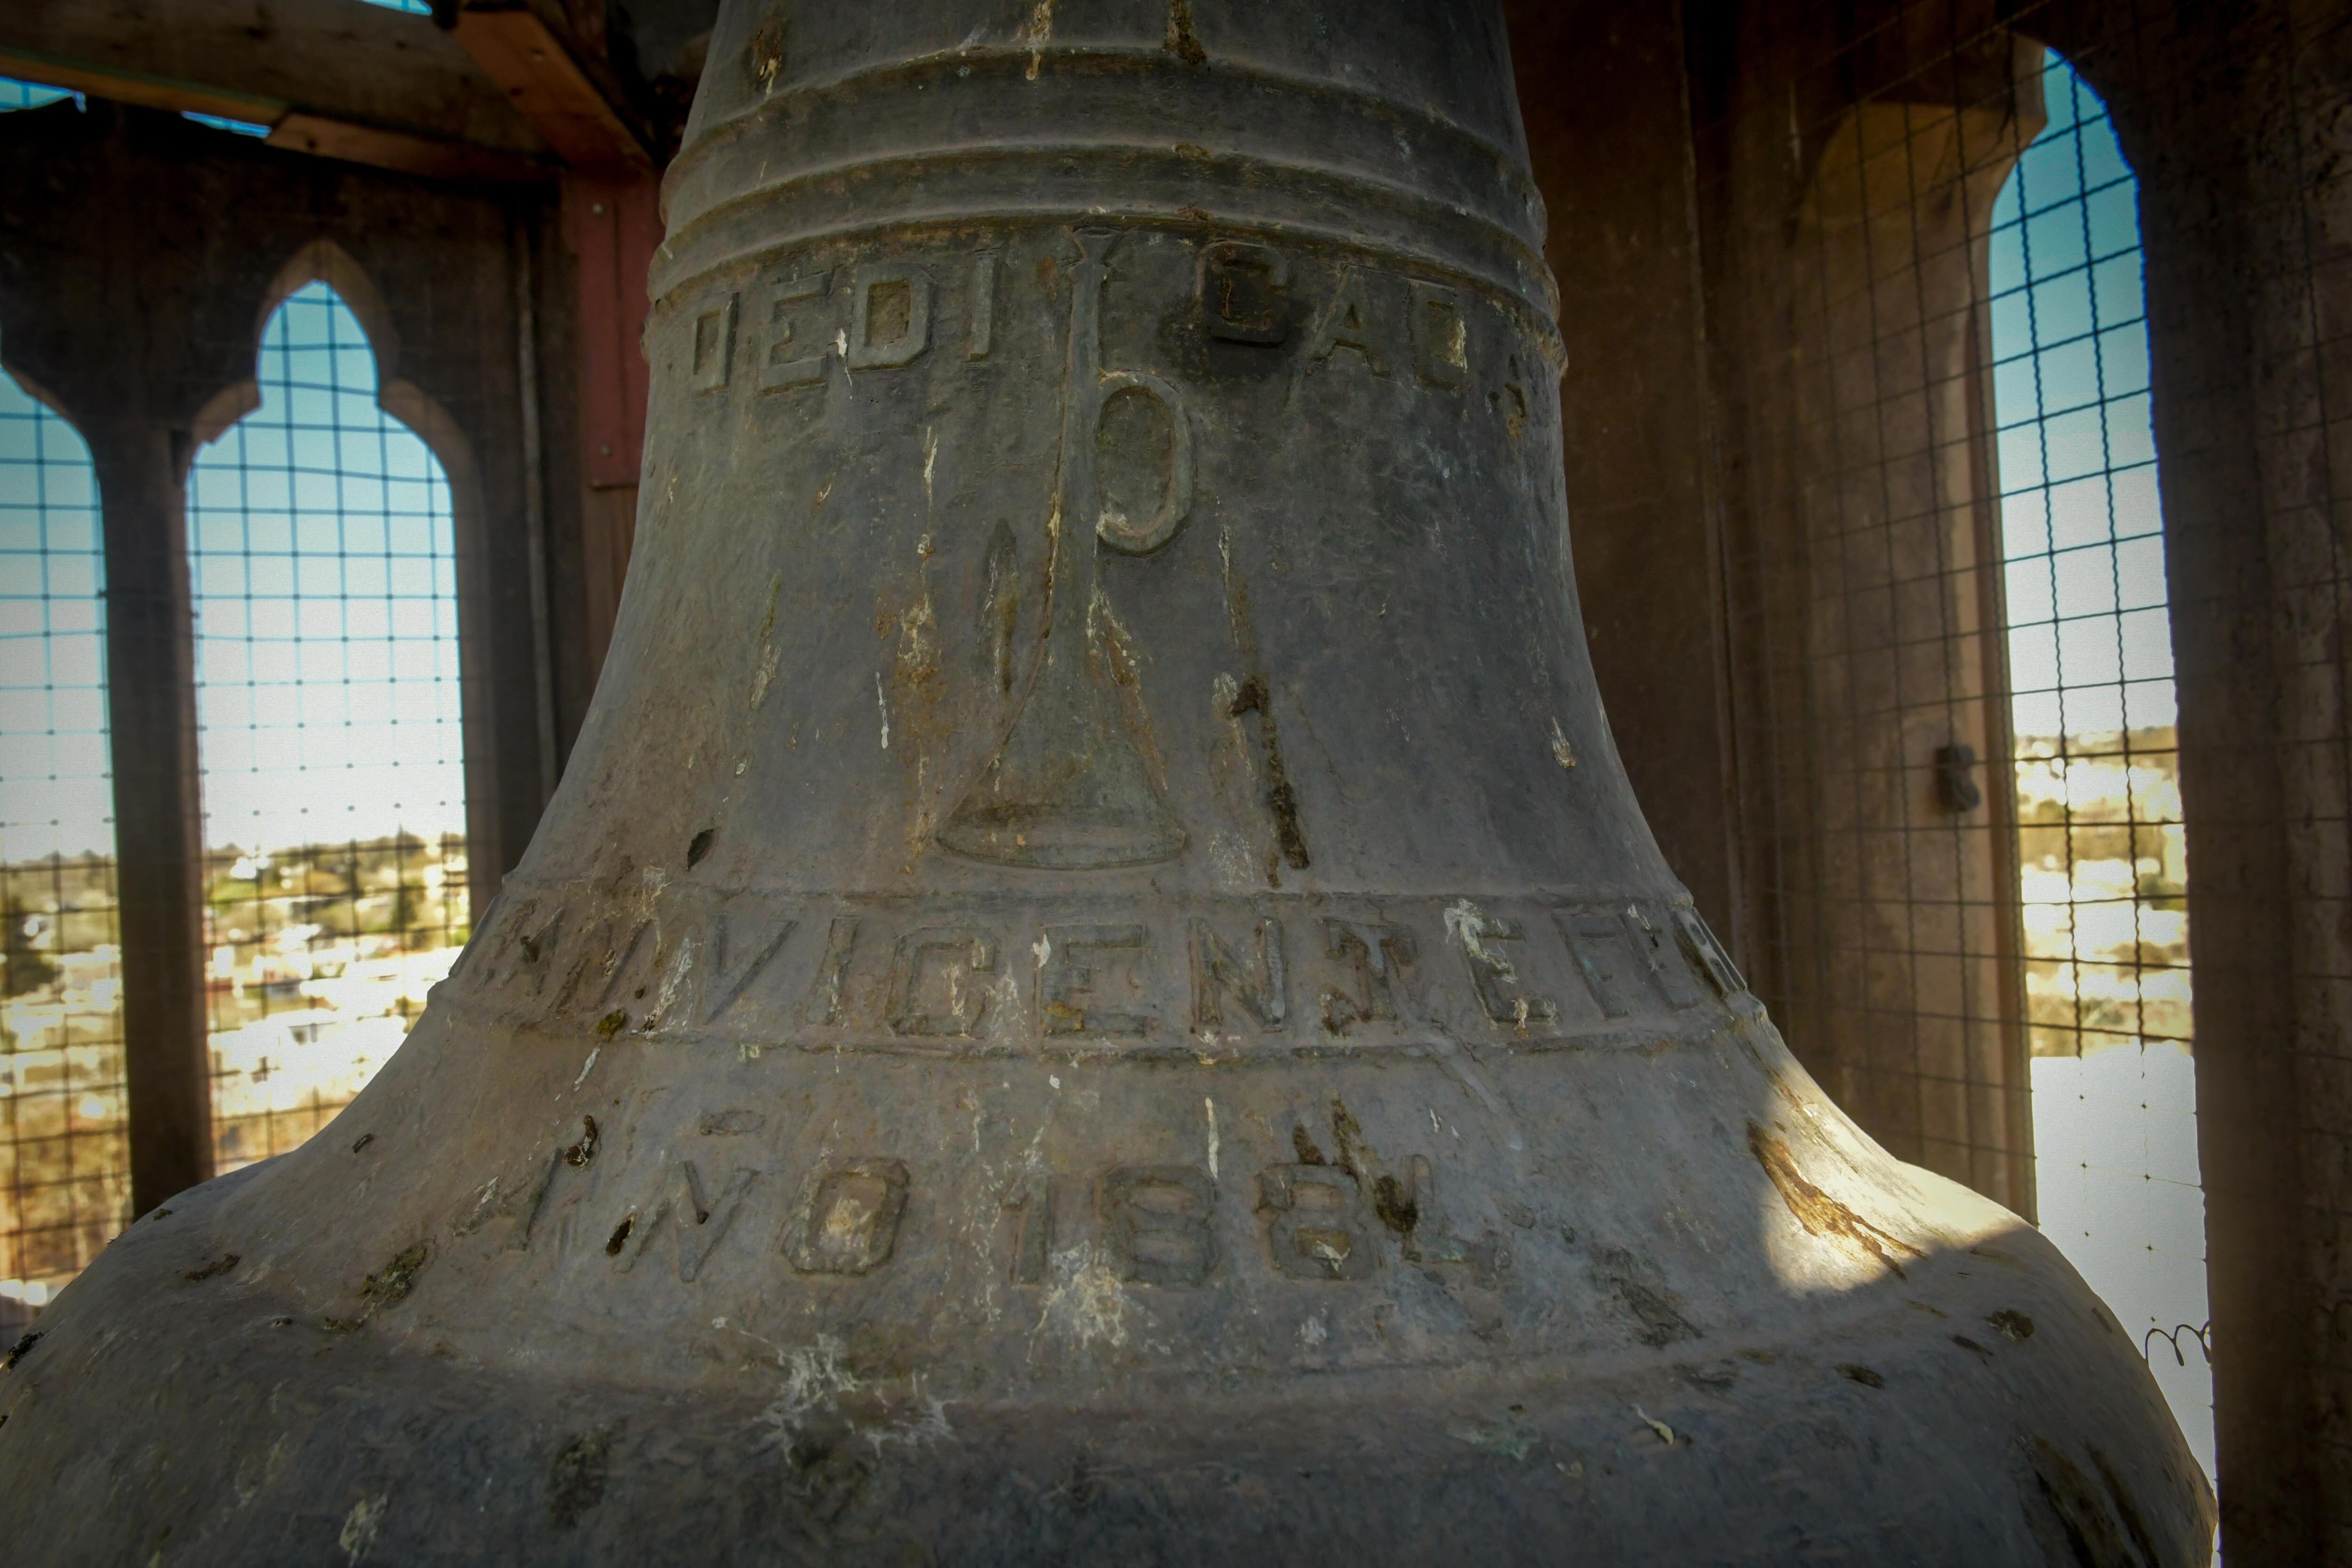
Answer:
[{"left": 0, "top": 835, "right": 468, "bottom": 1321}]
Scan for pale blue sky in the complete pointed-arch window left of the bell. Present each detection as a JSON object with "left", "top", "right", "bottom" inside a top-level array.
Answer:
[{"left": 188, "top": 282, "right": 466, "bottom": 849}]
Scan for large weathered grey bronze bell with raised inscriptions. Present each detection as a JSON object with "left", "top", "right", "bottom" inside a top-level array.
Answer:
[{"left": 0, "top": 0, "right": 2213, "bottom": 1568}]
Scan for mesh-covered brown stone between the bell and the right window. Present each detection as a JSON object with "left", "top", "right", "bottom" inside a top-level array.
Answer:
[{"left": 1736, "top": 12, "right": 2032, "bottom": 1210}]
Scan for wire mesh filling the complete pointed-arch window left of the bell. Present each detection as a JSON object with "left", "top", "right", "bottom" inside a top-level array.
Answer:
[{"left": 188, "top": 282, "right": 470, "bottom": 1171}]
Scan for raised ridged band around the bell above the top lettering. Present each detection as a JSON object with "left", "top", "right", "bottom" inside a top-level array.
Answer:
[{"left": 652, "top": 49, "right": 1557, "bottom": 319}]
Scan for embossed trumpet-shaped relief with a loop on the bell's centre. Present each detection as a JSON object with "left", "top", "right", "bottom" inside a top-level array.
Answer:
[{"left": 938, "top": 231, "right": 1192, "bottom": 870}]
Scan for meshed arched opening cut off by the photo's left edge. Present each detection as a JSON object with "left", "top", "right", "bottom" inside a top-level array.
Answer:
[{"left": 0, "top": 341, "right": 132, "bottom": 1326}]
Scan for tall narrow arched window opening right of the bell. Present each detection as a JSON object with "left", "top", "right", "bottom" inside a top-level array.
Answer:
[{"left": 1990, "top": 54, "right": 2213, "bottom": 1472}]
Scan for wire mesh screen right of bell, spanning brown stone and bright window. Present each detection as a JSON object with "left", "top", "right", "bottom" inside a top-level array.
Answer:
[{"left": 1698, "top": 0, "right": 2213, "bottom": 1472}]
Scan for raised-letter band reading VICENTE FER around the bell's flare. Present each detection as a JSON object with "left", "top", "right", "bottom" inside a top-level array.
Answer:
[{"left": 454, "top": 889, "right": 1743, "bottom": 1060}]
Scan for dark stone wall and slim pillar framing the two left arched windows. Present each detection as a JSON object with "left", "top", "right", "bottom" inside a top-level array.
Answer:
[{"left": 0, "top": 99, "right": 560, "bottom": 1210}]
